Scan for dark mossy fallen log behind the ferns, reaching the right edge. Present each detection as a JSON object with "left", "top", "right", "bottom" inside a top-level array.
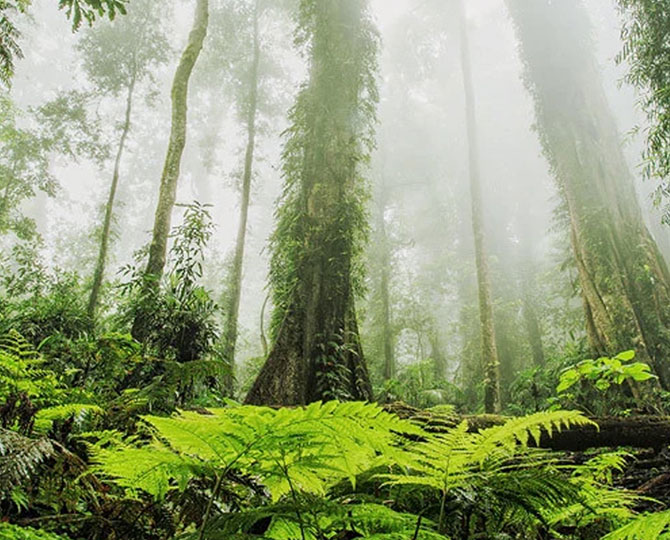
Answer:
[{"left": 385, "top": 403, "right": 670, "bottom": 452}]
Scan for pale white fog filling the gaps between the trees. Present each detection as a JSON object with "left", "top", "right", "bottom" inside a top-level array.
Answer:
[{"left": 4, "top": 0, "right": 670, "bottom": 402}]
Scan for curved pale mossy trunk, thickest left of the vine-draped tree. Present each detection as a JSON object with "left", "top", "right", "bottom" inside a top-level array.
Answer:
[{"left": 132, "top": 0, "right": 209, "bottom": 339}]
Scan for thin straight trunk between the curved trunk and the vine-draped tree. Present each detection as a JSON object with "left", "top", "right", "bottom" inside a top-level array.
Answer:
[{"left": 223, "top": 0, "right": 261, "bottom": 394}]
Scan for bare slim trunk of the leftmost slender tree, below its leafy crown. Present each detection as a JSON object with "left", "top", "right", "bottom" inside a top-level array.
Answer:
[{"left": 87, "top": 71, "right": 137, "bottom": 320}]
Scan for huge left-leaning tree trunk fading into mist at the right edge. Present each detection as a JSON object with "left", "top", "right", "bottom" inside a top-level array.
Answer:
[{"left": 507, "top": 0, "right": 670, "bottom": 388}]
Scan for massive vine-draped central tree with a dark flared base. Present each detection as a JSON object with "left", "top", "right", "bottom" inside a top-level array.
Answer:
[{"left": 246, "top": 0, "right": 377, "bottom": 405}]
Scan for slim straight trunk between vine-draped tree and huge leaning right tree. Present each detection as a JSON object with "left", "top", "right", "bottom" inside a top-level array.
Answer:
[{"left": 458, "top": 0, "right": 500, "bottom": 413}]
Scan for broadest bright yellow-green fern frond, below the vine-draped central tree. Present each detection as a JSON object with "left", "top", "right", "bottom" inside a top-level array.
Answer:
[{"left": 95, "top": 402, "right": 421, "bottom": 502}]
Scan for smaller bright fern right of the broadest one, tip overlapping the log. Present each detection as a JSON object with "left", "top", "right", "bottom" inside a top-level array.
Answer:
[{"left": 379, "top": 411, "right": 592, "bottom": 532}]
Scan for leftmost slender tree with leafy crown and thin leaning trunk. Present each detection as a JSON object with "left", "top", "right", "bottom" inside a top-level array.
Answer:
[{"left": 78, "top": 0, "right": 170, "bottom": 318}]
